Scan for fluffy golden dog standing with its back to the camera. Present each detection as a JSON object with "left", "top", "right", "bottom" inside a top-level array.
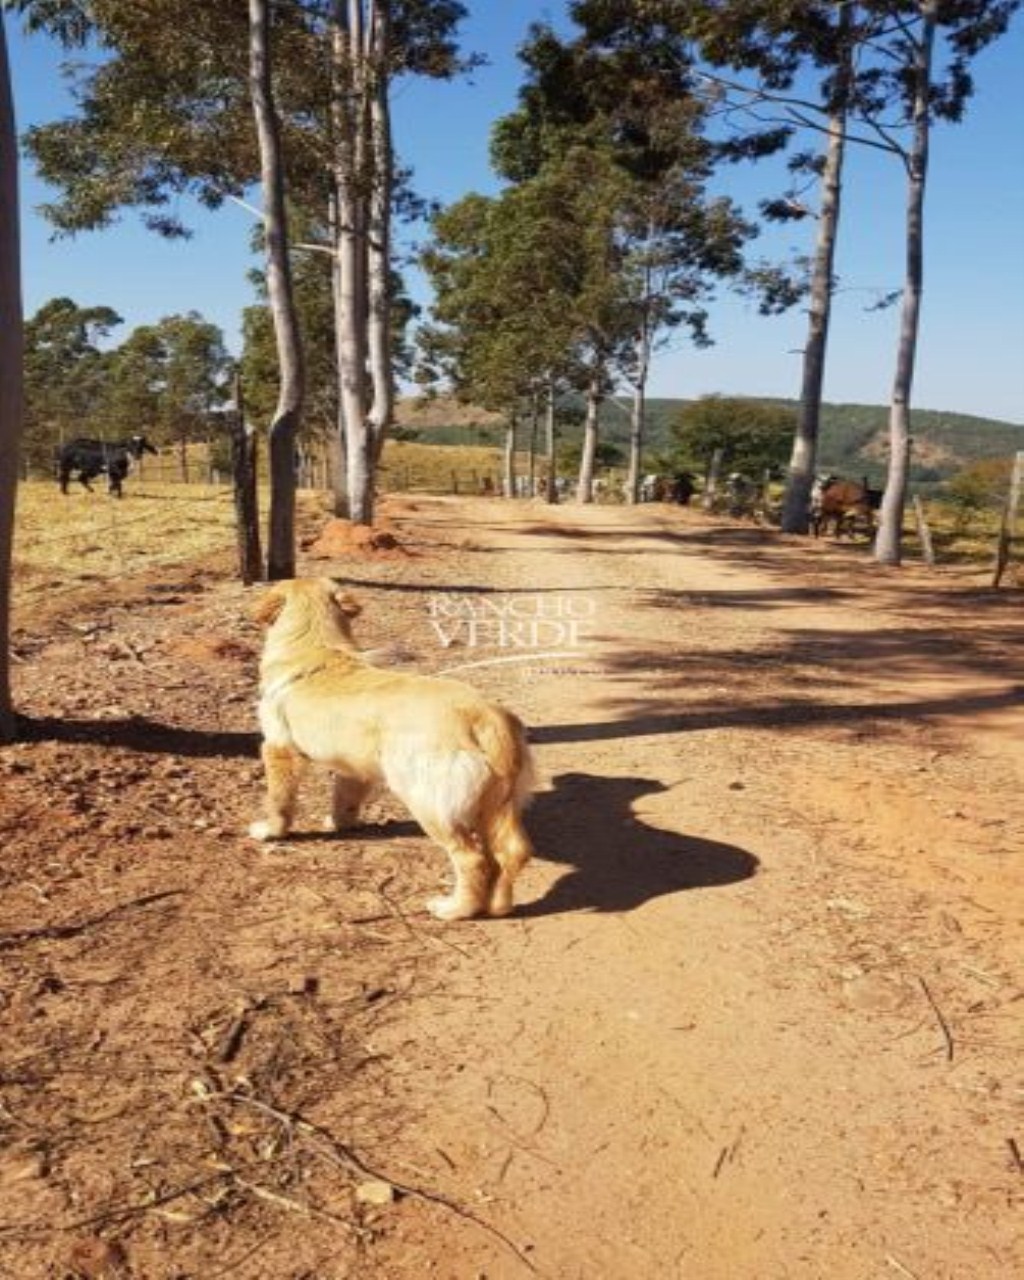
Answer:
[{"left": 250, "top": 579, "right": 532, "bottom": 920}]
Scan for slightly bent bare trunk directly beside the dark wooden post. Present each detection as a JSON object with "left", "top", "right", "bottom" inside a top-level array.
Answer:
[{"left": 248, "top": 0, "right": 305, "bottom": 581}]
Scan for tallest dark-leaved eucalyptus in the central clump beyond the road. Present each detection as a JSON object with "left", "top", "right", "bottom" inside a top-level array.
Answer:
[{"left": 492, "top": 16, "right": 774, "bottom": 502}]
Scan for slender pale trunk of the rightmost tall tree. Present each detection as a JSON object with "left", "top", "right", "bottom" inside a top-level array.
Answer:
[{"left": 874, "top": 0, "right": 937, "bottom": 564}]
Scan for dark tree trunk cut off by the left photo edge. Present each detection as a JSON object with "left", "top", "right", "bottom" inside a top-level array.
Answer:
[{"left": 0, "top": 18, "right": 23, "bottom": 742}]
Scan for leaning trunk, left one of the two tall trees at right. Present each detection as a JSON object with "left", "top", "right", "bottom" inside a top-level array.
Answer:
[{"left": 782, "top": 5, "right": 854, "bottom": 534}]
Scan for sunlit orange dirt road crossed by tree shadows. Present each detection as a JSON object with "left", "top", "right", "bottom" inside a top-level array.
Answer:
[{"left": 358, "top": 502, "right": 1024, "bottom": 1280}]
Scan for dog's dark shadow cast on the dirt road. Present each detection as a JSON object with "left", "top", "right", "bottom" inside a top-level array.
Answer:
[{"left": 515, "top": 773, "right": 759, "bottom": 919}]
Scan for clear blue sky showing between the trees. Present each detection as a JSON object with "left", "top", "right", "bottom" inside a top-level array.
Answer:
[{"left": 5, "top": 0, "right": 1024, "bottom": 422}]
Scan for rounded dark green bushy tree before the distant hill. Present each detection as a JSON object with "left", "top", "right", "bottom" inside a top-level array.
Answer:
[{"left": 672, "top": 396, "right": 796, "bottom": 475}]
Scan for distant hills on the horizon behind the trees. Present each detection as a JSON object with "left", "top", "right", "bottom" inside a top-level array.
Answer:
[{"left": 398, "top": 397, "right": 1024, "bottom": 484}]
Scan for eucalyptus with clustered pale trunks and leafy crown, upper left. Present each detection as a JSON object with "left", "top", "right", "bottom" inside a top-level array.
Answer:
[{"left": 8, "top": 0, "right": 472, "bottom": 540}]
